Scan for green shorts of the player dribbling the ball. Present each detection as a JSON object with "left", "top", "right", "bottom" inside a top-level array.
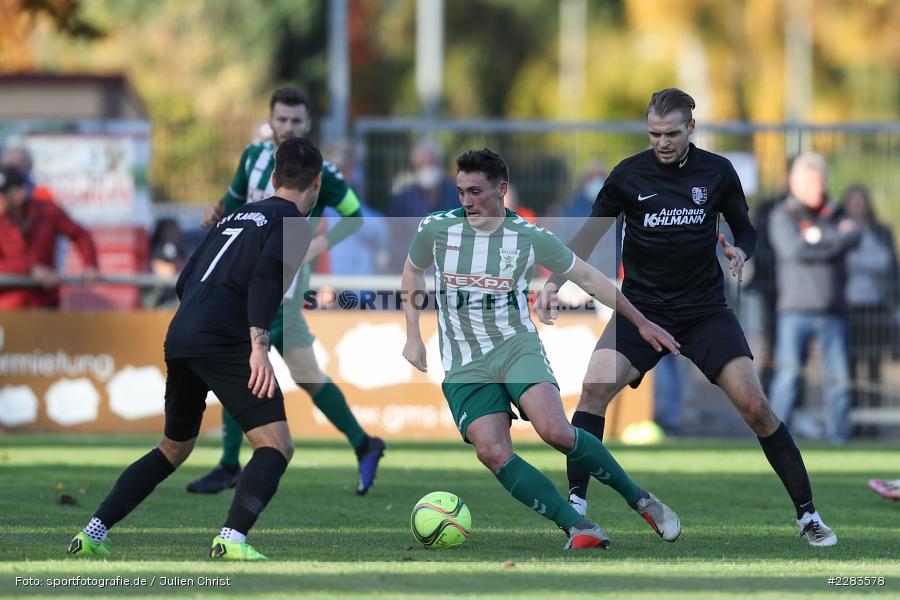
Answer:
[{"left": 441, "top": 333, "right": 559, "bottom": 443}]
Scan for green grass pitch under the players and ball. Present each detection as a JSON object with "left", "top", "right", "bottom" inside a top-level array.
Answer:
[{"left": 0, "top": 434, "right": 900, "bottom": 598}]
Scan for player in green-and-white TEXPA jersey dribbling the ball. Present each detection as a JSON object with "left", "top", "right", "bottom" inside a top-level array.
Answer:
[{"left": 402, "top": 148, "right": 681, "bottom": 549}]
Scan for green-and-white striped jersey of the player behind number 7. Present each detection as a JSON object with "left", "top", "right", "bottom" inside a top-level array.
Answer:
[{"left": 225, "top": 142, "right": 359, "bottom": 219}]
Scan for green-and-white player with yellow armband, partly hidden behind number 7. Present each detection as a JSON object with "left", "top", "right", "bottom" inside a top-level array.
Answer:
[{"left": 187, "top": 87, "right": 385, "bottom": 494}]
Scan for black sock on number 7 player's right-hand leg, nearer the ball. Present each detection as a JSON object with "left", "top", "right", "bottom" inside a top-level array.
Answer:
[{"left": 223, "top": 446, "right": 287, "bottom": 535}]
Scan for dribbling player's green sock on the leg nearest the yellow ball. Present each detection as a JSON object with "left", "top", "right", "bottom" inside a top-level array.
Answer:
[{"left": 495, "top": 454, "right": 582, "bottom": 529}]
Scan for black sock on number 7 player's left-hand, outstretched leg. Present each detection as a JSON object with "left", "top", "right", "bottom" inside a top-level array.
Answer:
[{"left": 94, "top": 448, "right": 175, "bottom": 528}]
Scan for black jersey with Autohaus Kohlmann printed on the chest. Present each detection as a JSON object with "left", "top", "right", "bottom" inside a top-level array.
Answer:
[{"left": 588, "top": 144, "right": 756, "bottom": 308}]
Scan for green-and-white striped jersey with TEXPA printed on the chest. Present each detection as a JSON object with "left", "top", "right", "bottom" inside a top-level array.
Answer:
[{"left": 409, "top": 208, "right": 576, "bottom": 371}]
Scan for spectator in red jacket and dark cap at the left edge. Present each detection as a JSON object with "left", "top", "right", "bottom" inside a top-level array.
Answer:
[{"left": 0, "top": 167, "right": 97, "bottom": 308}]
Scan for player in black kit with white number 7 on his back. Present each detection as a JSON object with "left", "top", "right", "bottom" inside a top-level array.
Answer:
[{"left": 68, "top": 138, "right": 322, "bottom": 560}]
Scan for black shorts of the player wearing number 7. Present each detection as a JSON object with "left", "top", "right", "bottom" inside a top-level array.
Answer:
[{"left": 165, "top": 358, "right": 287, "bottom": 442}]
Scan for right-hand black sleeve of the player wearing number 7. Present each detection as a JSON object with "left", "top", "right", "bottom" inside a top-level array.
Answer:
[{"left": 247, "top": 215, "right": 312, "bottom": 329}]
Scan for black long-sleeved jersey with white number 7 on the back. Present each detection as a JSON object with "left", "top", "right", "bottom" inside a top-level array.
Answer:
[{"left": 165, "top": 196, "right": 311, "bottom": 358}]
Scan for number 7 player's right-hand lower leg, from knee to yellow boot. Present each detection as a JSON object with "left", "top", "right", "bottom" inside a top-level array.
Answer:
[{"left": 209, "top": 421, "right": 294, "bottom": 560}]
